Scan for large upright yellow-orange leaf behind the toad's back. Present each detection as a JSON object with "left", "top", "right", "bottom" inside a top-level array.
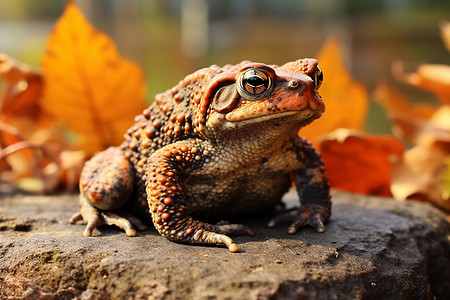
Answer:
[{"left": 42, "top": 1, "right": 146, "bottom": 154}]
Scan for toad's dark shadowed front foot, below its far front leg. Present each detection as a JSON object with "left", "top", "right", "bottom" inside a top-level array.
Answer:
[{"left": 267, "top": 204, "right": 330, "bottom": 234}]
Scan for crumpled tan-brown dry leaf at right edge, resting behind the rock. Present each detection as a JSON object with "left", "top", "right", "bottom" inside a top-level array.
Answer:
[{"left": 391, "top": 105, "right": 450, "bottom": 211}]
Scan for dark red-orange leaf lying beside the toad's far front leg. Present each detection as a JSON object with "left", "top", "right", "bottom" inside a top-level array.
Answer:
[{"left": 319, "top": 129, "right": 404, "bottom": 196}]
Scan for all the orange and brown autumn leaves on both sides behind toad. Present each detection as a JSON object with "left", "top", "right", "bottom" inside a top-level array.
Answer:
[{"left": 0, "top": 2, "right": 450, "bottom": 211}]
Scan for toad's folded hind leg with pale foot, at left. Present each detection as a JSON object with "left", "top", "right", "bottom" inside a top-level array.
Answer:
[{"left": 70, "top": 147, "right": 146, "bottom": 236}]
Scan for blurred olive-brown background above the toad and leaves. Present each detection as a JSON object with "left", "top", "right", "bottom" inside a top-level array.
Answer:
[{"left": 0, "top": 0, "right": 450, "bottom": 132}]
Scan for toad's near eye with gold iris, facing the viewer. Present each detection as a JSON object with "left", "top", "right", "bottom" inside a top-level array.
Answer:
[{"left": 238, "top": 69, "right": 272, "bottom": 99}]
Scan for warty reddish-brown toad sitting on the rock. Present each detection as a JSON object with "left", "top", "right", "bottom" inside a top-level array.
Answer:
[{"left": 71, "top": 59, "right": 331, "bottom": 252}]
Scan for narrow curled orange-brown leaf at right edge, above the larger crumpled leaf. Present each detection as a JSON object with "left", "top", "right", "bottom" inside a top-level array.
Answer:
[{"left": 392, "top": 62, "right": 450, "bottom": 104}]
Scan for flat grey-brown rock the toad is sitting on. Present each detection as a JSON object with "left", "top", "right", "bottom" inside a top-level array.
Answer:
[{"left": 0, "top": 192, "right": 450, "bottom": 299}]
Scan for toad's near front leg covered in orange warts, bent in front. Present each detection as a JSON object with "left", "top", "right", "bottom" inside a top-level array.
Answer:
[{"left": 146, "top": 141, "right": 252, "bottom": 252}]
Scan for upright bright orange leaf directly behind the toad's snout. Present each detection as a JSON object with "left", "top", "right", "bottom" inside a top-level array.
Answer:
[{"left": 300, "top": 39, "right": 369, "bottom": 143}]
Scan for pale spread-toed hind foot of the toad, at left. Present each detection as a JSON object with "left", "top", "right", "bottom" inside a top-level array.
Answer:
[{"left": 69, "top": 195, "right": 147, "bottom": 236}]
